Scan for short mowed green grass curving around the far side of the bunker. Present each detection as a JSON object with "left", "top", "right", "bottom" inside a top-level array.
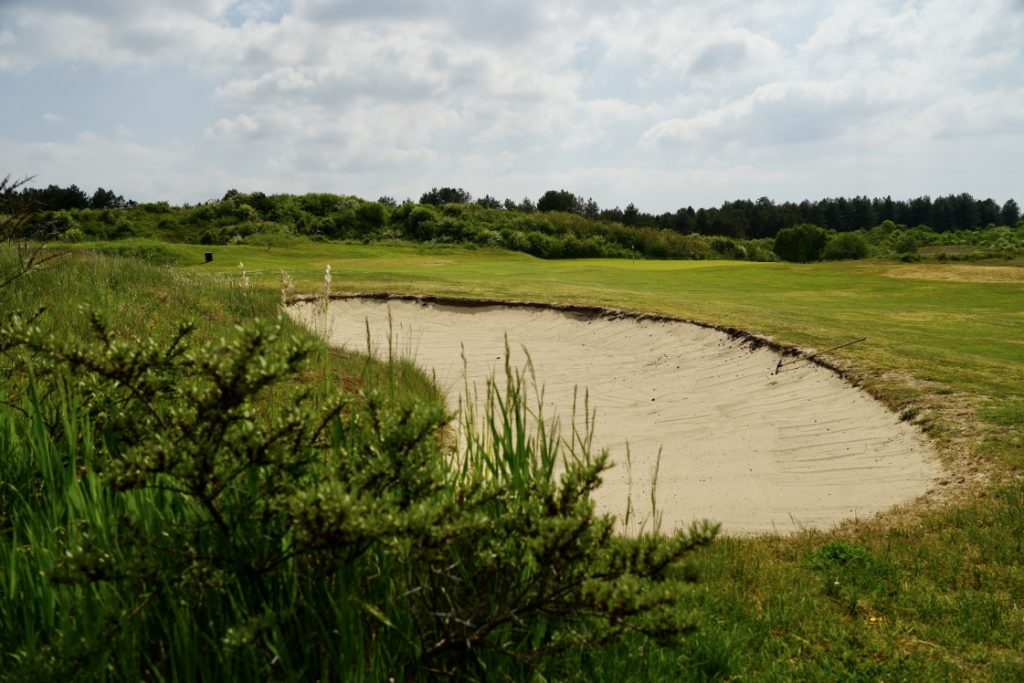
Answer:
[{"left": 97, "top": 244, "right": 1024, "bottom": 680}]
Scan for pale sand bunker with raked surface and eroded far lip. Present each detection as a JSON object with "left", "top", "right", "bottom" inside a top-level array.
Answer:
[{"left": 292, "top": 298, "right": 940, "bottom": 535}]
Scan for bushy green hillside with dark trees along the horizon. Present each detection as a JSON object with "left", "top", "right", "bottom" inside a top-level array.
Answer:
[{"left": 9, "top": 185, "right": 1024, "bottom": 261}]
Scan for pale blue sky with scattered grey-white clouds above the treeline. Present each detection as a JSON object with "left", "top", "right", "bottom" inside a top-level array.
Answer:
[{"left": 0, "top": 0, "right": 1024, "bottom": 212}]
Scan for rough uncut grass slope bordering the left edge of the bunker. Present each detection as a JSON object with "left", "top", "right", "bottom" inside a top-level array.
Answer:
[{"left": 0, "top": 250, "right": 439, "bottom": 444}]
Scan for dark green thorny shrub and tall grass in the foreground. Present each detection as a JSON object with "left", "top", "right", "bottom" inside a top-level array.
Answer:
[{"left": 0, "top": 305, "right": 715, "bottom": 680}]
